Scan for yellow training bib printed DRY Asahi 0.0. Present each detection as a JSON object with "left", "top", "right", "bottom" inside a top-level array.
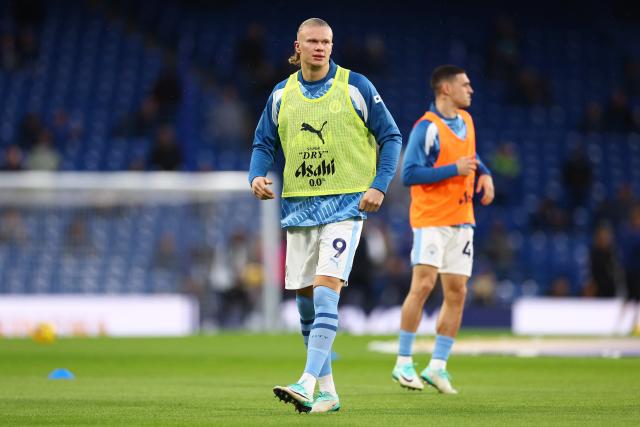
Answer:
[{"left": 278, "top": 67, "right": 376, "bottom": 197}]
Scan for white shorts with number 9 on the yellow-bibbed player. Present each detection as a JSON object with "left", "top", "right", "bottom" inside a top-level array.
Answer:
[{"left": 284, "top": 218, "right": 363, "bottom": 290}]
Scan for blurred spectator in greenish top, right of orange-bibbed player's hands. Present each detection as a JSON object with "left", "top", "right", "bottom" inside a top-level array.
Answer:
[{"left": 491, "top": 142, "right": 520, "bottom": 205}]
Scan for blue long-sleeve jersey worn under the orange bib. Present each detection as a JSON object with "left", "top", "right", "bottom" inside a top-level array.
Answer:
[{"left": 402, "top": 103, "right": 491, "bottom": 227}]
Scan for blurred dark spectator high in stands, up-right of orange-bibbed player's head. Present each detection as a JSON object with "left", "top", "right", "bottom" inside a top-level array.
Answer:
[{"left": 487, "top": 15, "right": 522, "bottom": 80}]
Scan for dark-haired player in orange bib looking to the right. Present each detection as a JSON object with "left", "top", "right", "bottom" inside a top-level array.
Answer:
[{"left": 392, "top": 65, "right": 494, "bottom": 394}]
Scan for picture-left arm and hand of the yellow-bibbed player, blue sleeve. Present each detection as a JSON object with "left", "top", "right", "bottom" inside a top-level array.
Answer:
[{"left": 249, "top": 86, "right": 281, "bottom": 200}]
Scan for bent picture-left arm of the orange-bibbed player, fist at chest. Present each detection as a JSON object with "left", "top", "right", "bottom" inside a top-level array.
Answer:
[{"left": 402, "top": 120, "right": 464, "bottom": 186}]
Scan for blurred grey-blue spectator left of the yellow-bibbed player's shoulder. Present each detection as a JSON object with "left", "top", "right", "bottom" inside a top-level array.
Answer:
[{"left": 209, "top": 85, "right": 251, "bottom": 150}]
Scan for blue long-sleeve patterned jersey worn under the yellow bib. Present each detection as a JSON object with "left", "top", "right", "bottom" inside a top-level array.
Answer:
[{"left": 249, "top": 61, "right": 402, "bottom": 228}]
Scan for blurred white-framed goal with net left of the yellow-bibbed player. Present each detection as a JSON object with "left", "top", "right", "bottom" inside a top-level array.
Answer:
[{"left": 0, "top": 172, "right": 281, "bottom": 329}]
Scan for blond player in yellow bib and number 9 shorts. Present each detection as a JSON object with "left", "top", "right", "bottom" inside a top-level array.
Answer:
[{"left": 249, "top": 18, "right": 402, "bottom": 412}]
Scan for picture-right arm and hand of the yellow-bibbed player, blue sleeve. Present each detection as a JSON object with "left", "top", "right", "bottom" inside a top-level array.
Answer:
[{"left": 349, "top": 72, "right": 402, "bottom": 212}]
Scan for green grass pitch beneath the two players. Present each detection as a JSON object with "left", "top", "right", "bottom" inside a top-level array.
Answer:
[{"left": 0, "top": 334, "right": 640, "bottom": 427}]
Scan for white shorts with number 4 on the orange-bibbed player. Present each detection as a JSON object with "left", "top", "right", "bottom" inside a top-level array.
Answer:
[{"left": 411, "top": 227, "right": 473, "bottom": 277}]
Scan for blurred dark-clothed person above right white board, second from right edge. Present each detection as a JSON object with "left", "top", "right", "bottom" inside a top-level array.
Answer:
[{"left": 585, "top": 224, "right": 621, "bottom": 298}]
